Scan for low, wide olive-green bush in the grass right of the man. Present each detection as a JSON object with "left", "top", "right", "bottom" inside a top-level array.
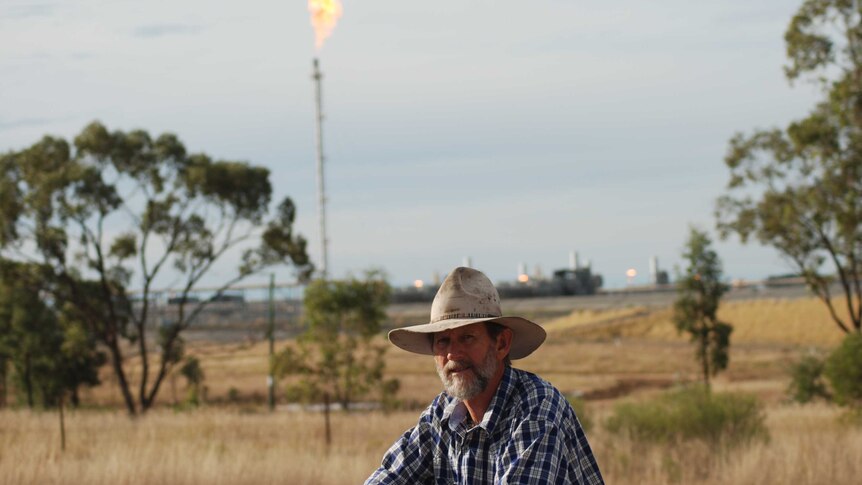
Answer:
[{"left": 605, "top": 387, "right": 768, "bottom": 448}]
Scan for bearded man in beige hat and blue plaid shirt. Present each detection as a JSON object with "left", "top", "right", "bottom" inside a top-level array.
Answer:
[{"left": 365, "top": 268, "right": 604, "bottom": 485}]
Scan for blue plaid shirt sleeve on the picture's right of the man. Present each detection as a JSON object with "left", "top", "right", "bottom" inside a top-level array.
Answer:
[{"left": 496, "top": 421, "right": 604, "bottom": 485}]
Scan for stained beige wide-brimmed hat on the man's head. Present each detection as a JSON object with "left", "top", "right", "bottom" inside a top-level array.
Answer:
[{"left": 389, "top": 267, "right": 546, "bottom": 359}]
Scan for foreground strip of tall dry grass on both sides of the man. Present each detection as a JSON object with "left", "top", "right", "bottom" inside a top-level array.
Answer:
[{"left": 0, "top": 406, "right": 862, "bottom": 485}]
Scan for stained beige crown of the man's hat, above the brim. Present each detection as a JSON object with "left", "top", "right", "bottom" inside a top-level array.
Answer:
[{"left": 431, "top": 266, "right": 503, "bottom": 323}]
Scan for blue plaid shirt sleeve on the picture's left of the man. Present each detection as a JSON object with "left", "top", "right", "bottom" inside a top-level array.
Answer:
[{"left": 365, "top": 423, "right": 434, "bottom": 485}]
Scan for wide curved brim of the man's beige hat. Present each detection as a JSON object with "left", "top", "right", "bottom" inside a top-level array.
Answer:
[{"left": 389, "top": 317, "right": 547, "bottom": 360}]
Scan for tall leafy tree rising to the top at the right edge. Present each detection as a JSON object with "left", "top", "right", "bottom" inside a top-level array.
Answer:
[{"left": 716, "top": 0, "right": 862, "bottom": 332}]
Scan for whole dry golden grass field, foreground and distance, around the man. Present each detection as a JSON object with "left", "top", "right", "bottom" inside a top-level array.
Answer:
[{"left": 0, "top": 299, "right": 862, "bottom": 484}]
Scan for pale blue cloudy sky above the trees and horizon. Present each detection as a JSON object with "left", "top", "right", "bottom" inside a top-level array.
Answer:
[{"left": 0, "top": 0, "right": 816, "bottom": 287}]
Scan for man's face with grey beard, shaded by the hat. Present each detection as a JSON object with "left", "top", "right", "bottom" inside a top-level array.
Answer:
[{"left": 433, "top": 323, "right": 501, "bottom": 401}]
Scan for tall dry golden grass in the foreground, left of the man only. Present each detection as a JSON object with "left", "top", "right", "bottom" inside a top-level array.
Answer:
[{"left": 0, "top": 409, "right": 406, "bottom": 484}]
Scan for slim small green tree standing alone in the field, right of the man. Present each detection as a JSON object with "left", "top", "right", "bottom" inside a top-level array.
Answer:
[{"left": 673, "top": 228, "right": 733, "bottom": 390}]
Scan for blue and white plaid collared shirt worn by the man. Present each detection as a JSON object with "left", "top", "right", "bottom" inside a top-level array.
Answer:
[{"left": 365, "top": 367, "right": 604, "bottom": 485}]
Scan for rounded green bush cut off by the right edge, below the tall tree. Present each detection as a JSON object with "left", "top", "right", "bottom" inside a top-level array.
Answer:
[{"left": 824, "top": 333, "right": 862, "bottom": 408}]
